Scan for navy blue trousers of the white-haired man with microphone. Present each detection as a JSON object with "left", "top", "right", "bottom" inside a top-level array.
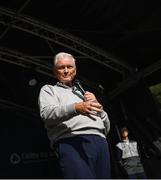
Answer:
[{"left": 55, "top": 135, "right": 111, "bottom": 179}]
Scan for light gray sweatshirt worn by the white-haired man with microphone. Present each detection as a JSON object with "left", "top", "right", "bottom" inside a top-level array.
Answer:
[{"left": 38, "top": 82, "right": 110, "bottom": 146}]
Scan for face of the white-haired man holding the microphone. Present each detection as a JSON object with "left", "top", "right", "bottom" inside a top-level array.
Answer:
[{"left": 54, "top": 57, "right": 76, "bottom": 86}]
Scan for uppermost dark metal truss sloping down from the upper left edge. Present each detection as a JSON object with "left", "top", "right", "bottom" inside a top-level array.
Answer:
[{"left": 0, "top": 8, "right": 133, "bottom": 74}]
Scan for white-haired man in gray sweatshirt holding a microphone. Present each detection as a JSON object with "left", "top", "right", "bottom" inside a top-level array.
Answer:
[{"left": 39, "top": 52, "right": 111, "bottom": 179}]
